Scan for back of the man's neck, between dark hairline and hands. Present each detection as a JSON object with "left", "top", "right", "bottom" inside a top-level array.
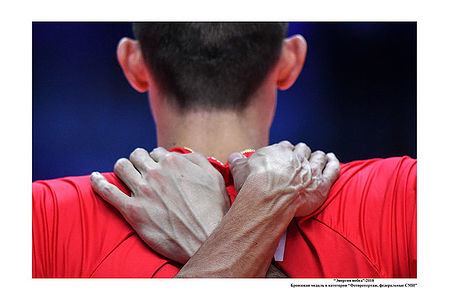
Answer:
[{"left": 150, "top": 73, "right": 277, "bottom": 163}]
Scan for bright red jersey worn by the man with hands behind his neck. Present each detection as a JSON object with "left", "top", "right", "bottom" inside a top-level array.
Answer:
[{"left": 33, "top": 148, "right": 416, "bottom": 278}]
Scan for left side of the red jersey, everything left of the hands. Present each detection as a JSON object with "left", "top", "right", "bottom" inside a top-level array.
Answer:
[{"left": 33, "top": 173, "right": 176, "bottom": 278}]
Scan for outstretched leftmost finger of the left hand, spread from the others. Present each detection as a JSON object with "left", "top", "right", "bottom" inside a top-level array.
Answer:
[{"left": 90, "top": 172, "right": 130, "bottom": 211}]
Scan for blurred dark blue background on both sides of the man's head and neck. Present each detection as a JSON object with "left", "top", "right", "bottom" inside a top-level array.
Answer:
[{"left": 32, "top": 22, "right": 416, "bottom": 181}]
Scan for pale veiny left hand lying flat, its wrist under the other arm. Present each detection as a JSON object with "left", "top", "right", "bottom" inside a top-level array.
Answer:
[{"left": 91, "top": 147, "right": 229, "bottom": 263}]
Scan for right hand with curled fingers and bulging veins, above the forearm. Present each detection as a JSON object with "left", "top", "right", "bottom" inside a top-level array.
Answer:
[{"left": 229, "top": 141, "right": 340, "bottom": 217}]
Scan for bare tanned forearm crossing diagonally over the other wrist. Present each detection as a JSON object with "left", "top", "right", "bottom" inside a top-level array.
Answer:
[{"left": 176, "top": 177, "right": 294, "bottom": 278}]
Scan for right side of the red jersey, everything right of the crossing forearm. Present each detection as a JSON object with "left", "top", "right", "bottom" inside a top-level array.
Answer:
[{"left": 280, "top": 157, "right": 417, "bottom": 278}]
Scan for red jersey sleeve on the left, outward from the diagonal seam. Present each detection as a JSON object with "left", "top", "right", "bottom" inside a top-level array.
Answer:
[{"left": 32, "top": 174, "right": 134, "bottom": 277}]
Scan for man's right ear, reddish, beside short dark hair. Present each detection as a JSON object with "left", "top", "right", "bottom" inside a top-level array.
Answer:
[{"left": 277, "top": 35, "right": 307, "bottom": 90}]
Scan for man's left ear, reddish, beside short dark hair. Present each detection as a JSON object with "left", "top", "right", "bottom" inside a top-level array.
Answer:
[{"left": 117, "top": 38, "right": 149, "bottom": 93}]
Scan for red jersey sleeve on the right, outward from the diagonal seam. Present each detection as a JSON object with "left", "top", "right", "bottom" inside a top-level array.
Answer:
[{"left": 316, "top": 157, "right": 417, "bottom": 277}]
